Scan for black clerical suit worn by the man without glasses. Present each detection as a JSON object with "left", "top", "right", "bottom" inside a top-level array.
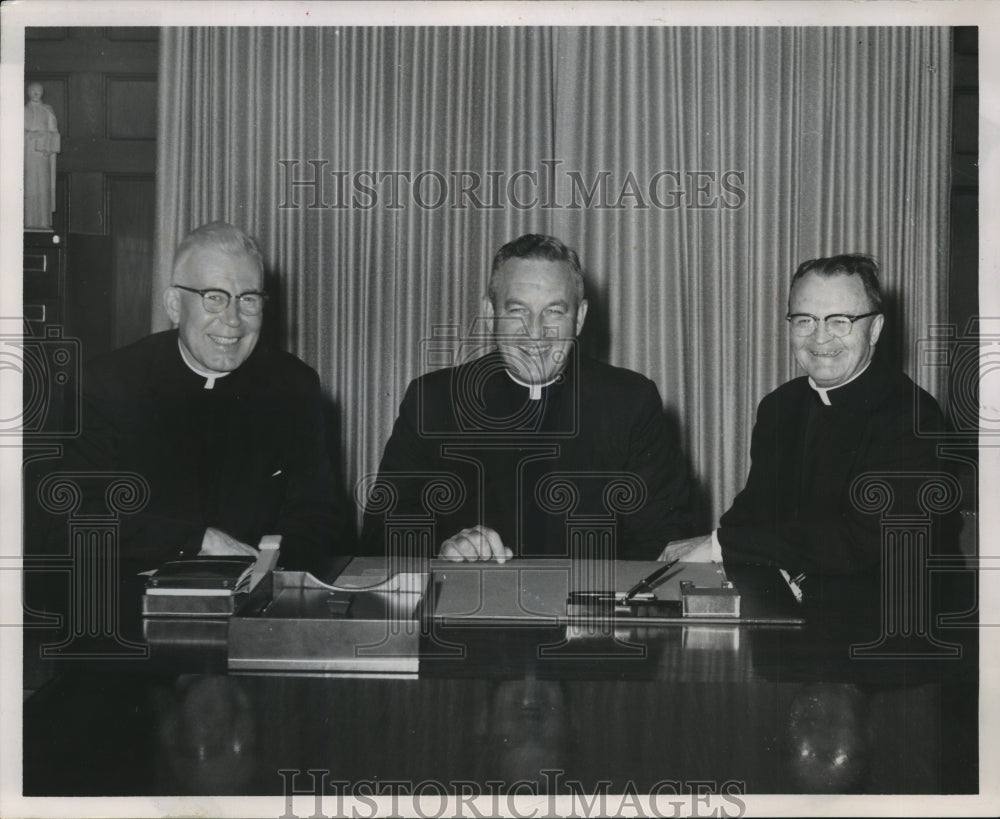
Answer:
[{"left": 363, "top": 352, "right": 689, "bottom": 559}]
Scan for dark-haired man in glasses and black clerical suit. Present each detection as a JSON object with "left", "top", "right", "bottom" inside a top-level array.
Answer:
[{"left": 661, "top": 254, "right": 944, "bottom": 575}]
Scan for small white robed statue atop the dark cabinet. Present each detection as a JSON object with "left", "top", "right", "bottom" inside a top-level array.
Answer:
[{"left": 24, "top": 82, "right": 60, "bottom": 230}]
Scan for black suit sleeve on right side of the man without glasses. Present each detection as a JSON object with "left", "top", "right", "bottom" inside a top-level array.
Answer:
[{"left": 620, "top": 380, "right": 691, "bottom": 560}]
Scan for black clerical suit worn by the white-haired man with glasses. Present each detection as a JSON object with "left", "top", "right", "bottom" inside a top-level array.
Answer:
[{"left": 63, "top": 330, "right": 344, "bottom": 572}]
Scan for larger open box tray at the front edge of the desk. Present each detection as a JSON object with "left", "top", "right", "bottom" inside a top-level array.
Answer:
[{"left": 229, "top": 571, "right": 429, "bottom": 674}]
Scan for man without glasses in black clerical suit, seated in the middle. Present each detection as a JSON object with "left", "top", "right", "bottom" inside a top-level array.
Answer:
[{"left": 363, "top": 234, "right": 689, "bottom": 562}]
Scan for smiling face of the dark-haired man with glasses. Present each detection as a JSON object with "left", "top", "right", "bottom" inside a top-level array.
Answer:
[{"left": 788, "top": 273, "right": 884, "bottom": 388}]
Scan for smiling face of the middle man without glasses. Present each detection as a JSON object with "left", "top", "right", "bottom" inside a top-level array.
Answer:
[{"left": 483, "top": 258, "right": 587, "bottom": 384}]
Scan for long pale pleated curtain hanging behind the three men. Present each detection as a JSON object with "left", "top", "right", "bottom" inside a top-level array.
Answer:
[{"left": 154, "top": 27, "right": 951, "bottom": 530}]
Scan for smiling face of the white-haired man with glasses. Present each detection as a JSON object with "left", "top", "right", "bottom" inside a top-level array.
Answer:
[{"left": 164, "top": 246, "right": 264, "bottom": 373}]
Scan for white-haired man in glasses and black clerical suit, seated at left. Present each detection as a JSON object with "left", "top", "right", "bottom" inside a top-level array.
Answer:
[{"left": 63, "top": 222, "right": 346, "bottom": 573}]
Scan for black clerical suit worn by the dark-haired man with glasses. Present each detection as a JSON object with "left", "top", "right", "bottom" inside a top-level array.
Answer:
[{"left": 718, "top": 357, "right": 950, "bottom": 574}]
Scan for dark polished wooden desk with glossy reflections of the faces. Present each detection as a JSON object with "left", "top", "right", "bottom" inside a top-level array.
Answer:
[{"left": 24, "top": 560, "right": 978, "bottom": 796}]
